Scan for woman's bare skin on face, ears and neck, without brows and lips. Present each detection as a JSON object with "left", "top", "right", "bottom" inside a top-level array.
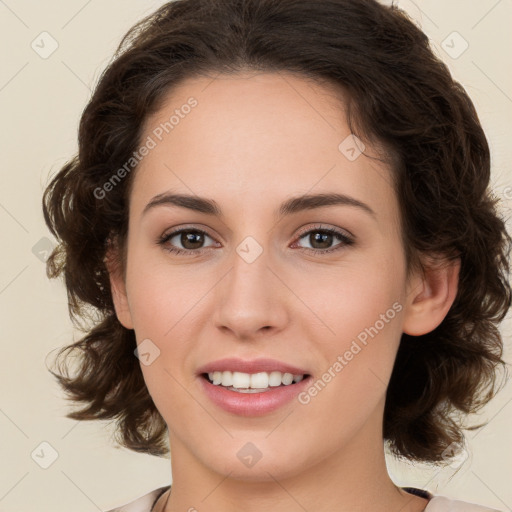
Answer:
[{"left": 110, "top": 73, "right": 458, "bottom": 512}]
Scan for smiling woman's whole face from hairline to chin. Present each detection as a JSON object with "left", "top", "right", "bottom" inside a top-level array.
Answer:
[{"left": 111, "top": 73, "right": 416, "bottom": 480}]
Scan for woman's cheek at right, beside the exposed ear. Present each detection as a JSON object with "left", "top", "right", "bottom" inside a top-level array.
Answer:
[{"left": 299, "top": 253, "right": 404, "bottom": 400}]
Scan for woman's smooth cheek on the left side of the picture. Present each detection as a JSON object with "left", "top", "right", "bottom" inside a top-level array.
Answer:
[{"left": 123, "top": 248, "right": 203, "bottom": 398}]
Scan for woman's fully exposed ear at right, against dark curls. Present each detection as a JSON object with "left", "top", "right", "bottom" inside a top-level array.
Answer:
[{"left": 402, "top": 259, "right": 460, "bottom": 336}]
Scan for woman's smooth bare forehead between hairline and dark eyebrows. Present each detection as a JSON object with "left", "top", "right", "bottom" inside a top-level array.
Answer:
[{"left": 134, "top": 73, "right": 393, "bottom": 223}]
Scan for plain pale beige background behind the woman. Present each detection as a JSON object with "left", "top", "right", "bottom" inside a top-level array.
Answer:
[{"left": 0, "top": 0, "right": 512, "bottom": 512}]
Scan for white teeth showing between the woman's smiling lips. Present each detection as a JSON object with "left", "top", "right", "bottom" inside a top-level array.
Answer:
[{"left": 201, "top": 370, "right": 310, "bottom": 394}]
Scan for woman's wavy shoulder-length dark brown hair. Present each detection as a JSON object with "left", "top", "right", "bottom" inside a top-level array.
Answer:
[{"left": 43, "top": 0, "right": 511, "bottom": 462}]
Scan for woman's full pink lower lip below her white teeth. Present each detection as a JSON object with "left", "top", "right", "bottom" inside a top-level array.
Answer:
[{"left": 199, "top": 376, "right": 311, "bottom": 416}]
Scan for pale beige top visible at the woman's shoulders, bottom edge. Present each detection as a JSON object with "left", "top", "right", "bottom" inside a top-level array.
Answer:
[{"left": 107, "top": 486, "right": 500, "bottom": 512}]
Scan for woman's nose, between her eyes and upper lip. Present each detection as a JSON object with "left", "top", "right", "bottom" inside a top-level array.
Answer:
[{"left": 214, "top": 243, "right": 291, "bottom": 340}]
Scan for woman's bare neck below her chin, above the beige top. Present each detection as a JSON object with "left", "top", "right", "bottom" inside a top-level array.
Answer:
[{"left": 159, "top": 400, "right": 428, "bottom": 512}]
